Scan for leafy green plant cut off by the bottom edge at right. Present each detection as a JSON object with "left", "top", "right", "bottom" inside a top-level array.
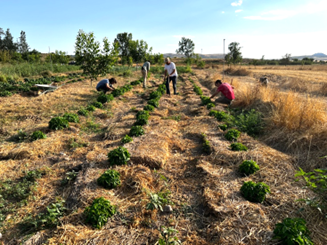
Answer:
[{"left": 273, "top": 218, "right": 313, "bottom": 245}]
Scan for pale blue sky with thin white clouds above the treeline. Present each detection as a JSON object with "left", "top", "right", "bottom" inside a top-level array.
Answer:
[{"left": 0, "top": 0, "right": 327, "bottom": 59}]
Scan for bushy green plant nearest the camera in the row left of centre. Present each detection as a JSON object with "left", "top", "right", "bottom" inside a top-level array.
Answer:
[{"left": 84, "top": 197, "right": 116, "bottom": 229}]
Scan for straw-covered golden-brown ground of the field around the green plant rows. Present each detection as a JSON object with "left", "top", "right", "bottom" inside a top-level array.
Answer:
[{"left": 0, "top": 67, "right": 327, "bottom": 244}]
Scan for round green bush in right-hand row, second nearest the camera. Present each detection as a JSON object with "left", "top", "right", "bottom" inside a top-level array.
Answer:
[{"left": 241, "top": 181, "right": 270, "bottom": 203}]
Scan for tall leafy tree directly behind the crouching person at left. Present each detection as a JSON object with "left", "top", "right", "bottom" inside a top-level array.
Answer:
[{"left": 75, "top": 30, "right": 119, "bottom": 86}]
